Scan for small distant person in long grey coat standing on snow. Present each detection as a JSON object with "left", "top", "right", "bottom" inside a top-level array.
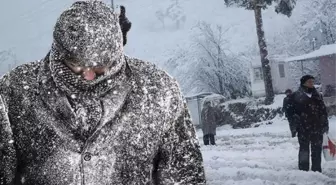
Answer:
[{"left": 201, "top": 101, "right": 217, "bottom": 145}]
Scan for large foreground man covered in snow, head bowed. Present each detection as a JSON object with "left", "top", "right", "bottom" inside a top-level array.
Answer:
[{"left": 0, "top": 1, "right": 205, "bottom": 185}]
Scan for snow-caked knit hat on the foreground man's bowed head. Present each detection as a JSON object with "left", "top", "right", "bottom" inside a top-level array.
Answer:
[{"left": 51, "top": 1, "right": 123, "bottom": 67}]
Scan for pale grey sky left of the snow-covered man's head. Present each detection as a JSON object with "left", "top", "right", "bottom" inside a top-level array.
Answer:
[{"left": 0, "top": 0, "right": 77, "bottom": 63}]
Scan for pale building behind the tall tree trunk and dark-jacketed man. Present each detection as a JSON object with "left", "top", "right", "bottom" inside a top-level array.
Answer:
[{"left": 250, "top": 44, "right": 336, "bottom": 97}]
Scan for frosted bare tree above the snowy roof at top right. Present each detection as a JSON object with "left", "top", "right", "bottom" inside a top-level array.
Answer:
[{"left": 267, "top": 0, "right": 336, "bottom": 56}]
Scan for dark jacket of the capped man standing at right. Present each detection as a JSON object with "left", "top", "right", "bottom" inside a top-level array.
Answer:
[{"left": 288, "top": 87, "right": 329, "bottom": 134}]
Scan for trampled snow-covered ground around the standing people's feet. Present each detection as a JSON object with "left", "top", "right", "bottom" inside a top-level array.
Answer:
[{"left": 198, "top": 118, "right": 336, "bottom": 185}]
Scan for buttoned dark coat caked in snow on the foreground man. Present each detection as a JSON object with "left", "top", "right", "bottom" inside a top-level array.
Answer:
[{"left": 0, "top": 58, "right": 205, "bottom": 185}]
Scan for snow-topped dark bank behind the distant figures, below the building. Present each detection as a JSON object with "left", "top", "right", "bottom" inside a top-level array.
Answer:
[{"left": 198, "top": 94, "right": 336, "bottom": 128}]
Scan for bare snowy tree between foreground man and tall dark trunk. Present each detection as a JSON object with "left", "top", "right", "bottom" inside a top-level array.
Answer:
[{"left": 196, "top": 23, "right": 249, "bottom": 98}]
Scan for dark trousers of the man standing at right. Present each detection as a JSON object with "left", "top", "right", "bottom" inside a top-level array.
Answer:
[{"left": 298, "top": 131, "right": 323, "bottom": 172}]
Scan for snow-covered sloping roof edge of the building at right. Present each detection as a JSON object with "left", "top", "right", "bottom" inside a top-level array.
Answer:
[{"left": 285, "top": 44, "right": 336, "bottom": 62}]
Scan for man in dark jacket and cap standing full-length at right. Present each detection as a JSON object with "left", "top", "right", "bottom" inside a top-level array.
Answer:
[{"left": 289, "top": 75, "right": 329, "bottom": 172}]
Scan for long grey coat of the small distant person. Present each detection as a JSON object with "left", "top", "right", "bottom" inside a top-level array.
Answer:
[{"left": 201, "top": 104, "right": 217, "bottom": 135}]
